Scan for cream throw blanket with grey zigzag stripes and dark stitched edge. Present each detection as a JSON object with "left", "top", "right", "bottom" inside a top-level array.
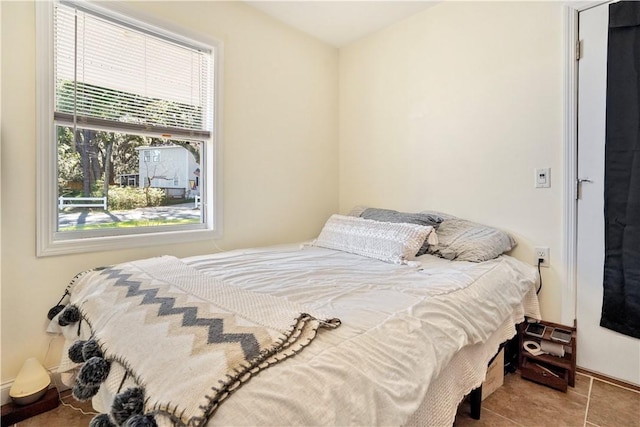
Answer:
[{"left": 60, "top": 256, "right": 340, "bottom": 426}]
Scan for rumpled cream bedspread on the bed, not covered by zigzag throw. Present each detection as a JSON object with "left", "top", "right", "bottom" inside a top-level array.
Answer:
[{"left": 61, "top": 245, "right": 540, "bottom": 426}]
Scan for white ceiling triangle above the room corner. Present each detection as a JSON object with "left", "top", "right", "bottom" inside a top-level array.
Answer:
[{"left": 246, "top": 0, "right": 438, "bottom": 47}]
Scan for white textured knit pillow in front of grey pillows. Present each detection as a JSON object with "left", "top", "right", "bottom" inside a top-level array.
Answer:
[{"left": 314, "top": 215, "right": 433, "bottom": 264}]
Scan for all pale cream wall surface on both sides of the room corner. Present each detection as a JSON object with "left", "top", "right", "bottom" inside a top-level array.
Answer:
[{"left": 0, "top": 2, "right": 564, "bottom": 390}]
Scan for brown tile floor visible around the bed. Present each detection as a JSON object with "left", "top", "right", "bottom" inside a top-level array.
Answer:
[{"left": 6, "top": 373, "right": 640, "bottom": 427}]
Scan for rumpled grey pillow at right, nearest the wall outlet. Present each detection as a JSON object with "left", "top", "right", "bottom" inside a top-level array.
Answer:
[{"left": 428, "top": 218, "right": 516, "bottom": 262}]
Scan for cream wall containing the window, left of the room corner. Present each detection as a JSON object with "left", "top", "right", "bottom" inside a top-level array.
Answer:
[{"left": 1, "top": 1, "right": 338, "bottom": 383}]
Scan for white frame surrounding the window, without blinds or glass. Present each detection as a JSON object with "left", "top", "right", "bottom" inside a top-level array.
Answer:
[{"left": 36, "top": 0, "right": 224, "bottom": 257}]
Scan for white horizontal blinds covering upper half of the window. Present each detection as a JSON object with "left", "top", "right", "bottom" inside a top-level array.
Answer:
[{"left": 54, "top": 3, "right": 213, "bottom": 138}]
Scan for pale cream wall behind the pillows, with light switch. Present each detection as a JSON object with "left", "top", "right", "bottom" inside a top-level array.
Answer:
[{"left": 340, "top": 2, "right": 564, "bottom": 321}]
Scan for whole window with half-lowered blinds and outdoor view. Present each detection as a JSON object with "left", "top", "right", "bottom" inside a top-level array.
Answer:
[{"left": 37, "top": 1, "right": 221, "bottom": 255}]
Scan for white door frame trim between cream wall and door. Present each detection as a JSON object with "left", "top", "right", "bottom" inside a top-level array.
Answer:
[{"left": 561, "top": 0, "right": 611, "bottom": 325}]
